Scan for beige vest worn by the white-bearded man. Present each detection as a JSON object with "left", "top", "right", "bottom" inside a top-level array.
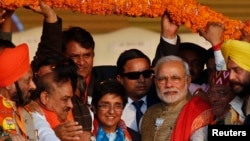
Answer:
[{"left": 141, "top": 102, "right": 186, "bottom": 141}]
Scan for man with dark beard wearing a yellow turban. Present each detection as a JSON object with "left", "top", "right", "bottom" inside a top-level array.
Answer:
[{"left": 221, "top": 40, "right": 250, "bottom": 124}]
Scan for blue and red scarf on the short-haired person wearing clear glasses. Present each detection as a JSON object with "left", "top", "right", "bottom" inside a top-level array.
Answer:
[{"left": 93, "top": 118, "right": 132, "bottom": 141}]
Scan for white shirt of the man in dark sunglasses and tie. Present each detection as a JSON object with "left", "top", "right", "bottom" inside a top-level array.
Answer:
[{"left": 121, "top": 96, "right": 147, "bottom": 132}]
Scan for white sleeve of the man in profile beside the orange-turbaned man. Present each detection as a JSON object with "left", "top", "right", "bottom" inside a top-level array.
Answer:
[{"left": 32, "top": 112, "right": 60, "bottom": 141}]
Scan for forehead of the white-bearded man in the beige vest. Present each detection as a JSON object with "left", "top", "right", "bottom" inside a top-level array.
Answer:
[{"left": 157, "top": 61, "right": 185, "bottom": 75}]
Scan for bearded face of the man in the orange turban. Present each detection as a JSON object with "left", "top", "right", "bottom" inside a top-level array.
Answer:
[{"left": 10, "top": 69, "right": 36, "bottom": 106}]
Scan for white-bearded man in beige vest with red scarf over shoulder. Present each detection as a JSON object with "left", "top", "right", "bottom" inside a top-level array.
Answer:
[{"left": 140, "top": 55, "right": 210, "bottom": 141}]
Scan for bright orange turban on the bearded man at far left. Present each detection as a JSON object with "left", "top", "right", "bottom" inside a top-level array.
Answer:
[{"left": 0, "top": 44, "right": 30, "bottom": 87}]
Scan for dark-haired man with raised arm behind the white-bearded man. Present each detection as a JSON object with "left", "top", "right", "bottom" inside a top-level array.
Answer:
[{"left": 152, "top": 13, "right": 208, "bottom": 94}]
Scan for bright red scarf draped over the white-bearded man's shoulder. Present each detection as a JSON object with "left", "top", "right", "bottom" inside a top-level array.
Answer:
[{"left": 171, "top": 96, "right": 212, "bottom": 141}]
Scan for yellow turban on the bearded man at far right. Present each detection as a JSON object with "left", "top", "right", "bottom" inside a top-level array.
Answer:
[{"left": 221, "top": 39, "right": 250, "bottom": 72}]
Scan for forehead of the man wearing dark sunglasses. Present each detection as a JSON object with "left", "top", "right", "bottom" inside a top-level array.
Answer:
[{"left": 124, "top": 58, "right": 150, "bottom": 72}]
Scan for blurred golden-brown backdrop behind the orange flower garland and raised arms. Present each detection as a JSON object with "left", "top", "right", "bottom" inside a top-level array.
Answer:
[{"left": 12, "top": 0, "right": 250, "bottom": 34}]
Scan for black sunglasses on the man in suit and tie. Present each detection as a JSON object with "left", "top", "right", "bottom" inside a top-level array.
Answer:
[{"left": 122, "top": 70, "right": 154, "bottom": 80}]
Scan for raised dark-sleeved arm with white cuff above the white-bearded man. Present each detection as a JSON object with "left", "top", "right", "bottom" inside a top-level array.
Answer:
[{"left": 152, "top": 13, "right": 180, "bottom": 66}]
